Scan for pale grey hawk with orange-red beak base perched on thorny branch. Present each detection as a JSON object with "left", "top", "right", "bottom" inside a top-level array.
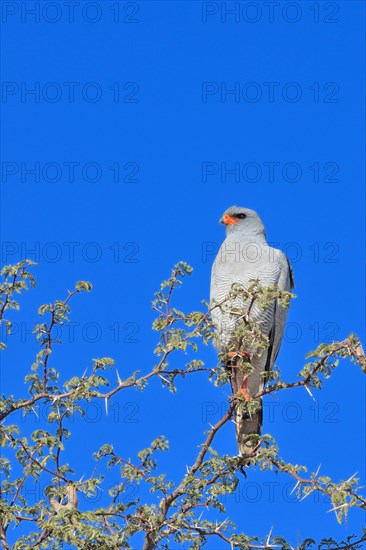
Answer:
[{"left": 211, "top": 206, "right": 294, "bottom": 456}]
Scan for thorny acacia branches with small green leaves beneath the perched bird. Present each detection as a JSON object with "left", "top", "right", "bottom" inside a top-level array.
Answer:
[{"left": 0, "top": 260, "right": 366, "bottom": 550}]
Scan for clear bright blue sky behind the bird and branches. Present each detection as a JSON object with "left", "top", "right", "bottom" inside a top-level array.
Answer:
[{"left": 1, "top": 1, "right": 365, "bottom": 550}]
